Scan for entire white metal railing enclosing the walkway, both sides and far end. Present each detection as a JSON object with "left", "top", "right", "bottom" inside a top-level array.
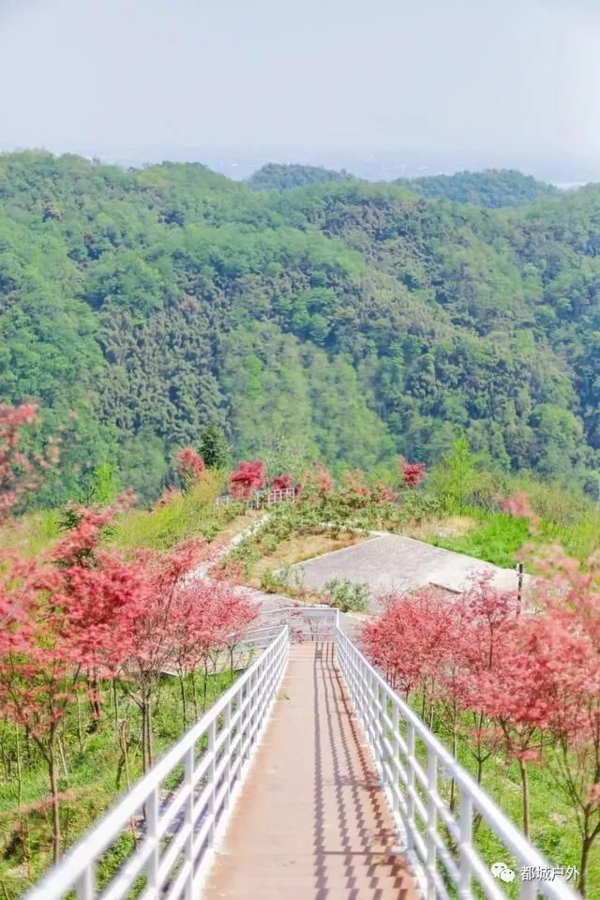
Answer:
[{"left": 25, "top": 607, "right": 579, "bottom": 900}]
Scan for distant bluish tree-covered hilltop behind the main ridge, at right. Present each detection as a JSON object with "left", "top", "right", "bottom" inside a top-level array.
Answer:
[{"left": 395, "top": 169, "right": 560, "bottom": 209}]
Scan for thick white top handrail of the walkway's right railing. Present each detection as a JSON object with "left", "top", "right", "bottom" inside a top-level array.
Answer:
[{"left": 336, "top": 625, "right": 579, "bottom": 900}]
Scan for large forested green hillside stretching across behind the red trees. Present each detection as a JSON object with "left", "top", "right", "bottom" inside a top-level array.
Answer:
[{"left": 0, "top": 152, "right": 600, "bottom": 502}]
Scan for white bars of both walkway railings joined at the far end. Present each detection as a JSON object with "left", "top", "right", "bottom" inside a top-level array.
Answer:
[{"left": 25, "top": 606, "right": 579, "bottom": 900}]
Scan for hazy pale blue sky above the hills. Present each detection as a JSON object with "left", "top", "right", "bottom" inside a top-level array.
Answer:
[{"left": 0, "top": 0, "right": 600, "bottom": 156}]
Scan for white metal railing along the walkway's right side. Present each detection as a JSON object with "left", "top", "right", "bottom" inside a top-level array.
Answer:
[{"left": 336, "top": 627, "right": 579, "bottom": 900}]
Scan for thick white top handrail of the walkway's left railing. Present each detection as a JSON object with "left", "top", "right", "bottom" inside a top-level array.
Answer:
[{"left": 25, "top": 625, "right": 288, "bottom": 900}]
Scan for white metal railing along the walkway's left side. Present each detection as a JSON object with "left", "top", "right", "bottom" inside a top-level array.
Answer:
[{"left": 26, "top": 626, "right": 289, "bottom": 900}]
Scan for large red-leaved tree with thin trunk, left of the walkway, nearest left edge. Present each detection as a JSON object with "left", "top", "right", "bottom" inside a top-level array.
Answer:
[{"left": 0, "top": 496, "right": 141, "bottom": 861}]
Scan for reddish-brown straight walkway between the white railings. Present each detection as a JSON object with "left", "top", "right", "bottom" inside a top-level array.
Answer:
[{"left": 202, "top": 642, "right": 419, "bottom": 900}]
